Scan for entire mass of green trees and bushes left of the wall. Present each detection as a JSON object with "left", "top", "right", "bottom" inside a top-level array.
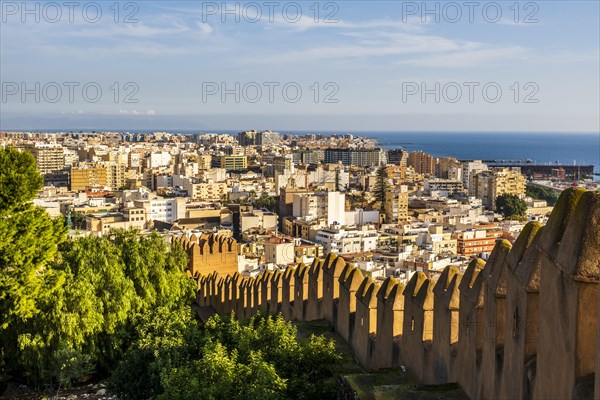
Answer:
[{"left": 0, "top": 149, "right": 339, "bottom": 399}]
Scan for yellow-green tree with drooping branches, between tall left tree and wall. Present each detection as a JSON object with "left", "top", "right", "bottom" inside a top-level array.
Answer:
[{"left": 2, "top": 231, "right": 194, "bottom": 383}]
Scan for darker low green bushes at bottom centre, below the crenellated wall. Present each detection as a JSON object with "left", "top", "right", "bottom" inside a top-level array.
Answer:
[{"left": 112, "top": 314, "right": 340, "bottom": 400}]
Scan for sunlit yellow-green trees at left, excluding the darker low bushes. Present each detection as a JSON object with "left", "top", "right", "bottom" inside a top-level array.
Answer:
[{"left": 0, "top": 148, "right": 194, "bottom": 385}]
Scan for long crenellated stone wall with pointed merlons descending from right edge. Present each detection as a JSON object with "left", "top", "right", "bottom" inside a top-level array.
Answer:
[{"left": 197, "top": 189, "right": 600, "bottom": 399}]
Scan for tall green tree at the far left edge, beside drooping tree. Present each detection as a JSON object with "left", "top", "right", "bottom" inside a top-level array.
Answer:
[{"left": 0, "top": 148, "right": 66, "bottom": 379}]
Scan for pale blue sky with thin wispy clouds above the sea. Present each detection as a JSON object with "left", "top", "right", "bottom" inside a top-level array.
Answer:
[{"left": 0, "top": 0, "right": 600, "bottom": 132}]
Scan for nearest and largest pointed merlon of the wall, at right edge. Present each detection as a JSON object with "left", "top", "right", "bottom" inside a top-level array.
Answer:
[{"left": 534, "top": 189, "right": 600, "bottom": 399}]
